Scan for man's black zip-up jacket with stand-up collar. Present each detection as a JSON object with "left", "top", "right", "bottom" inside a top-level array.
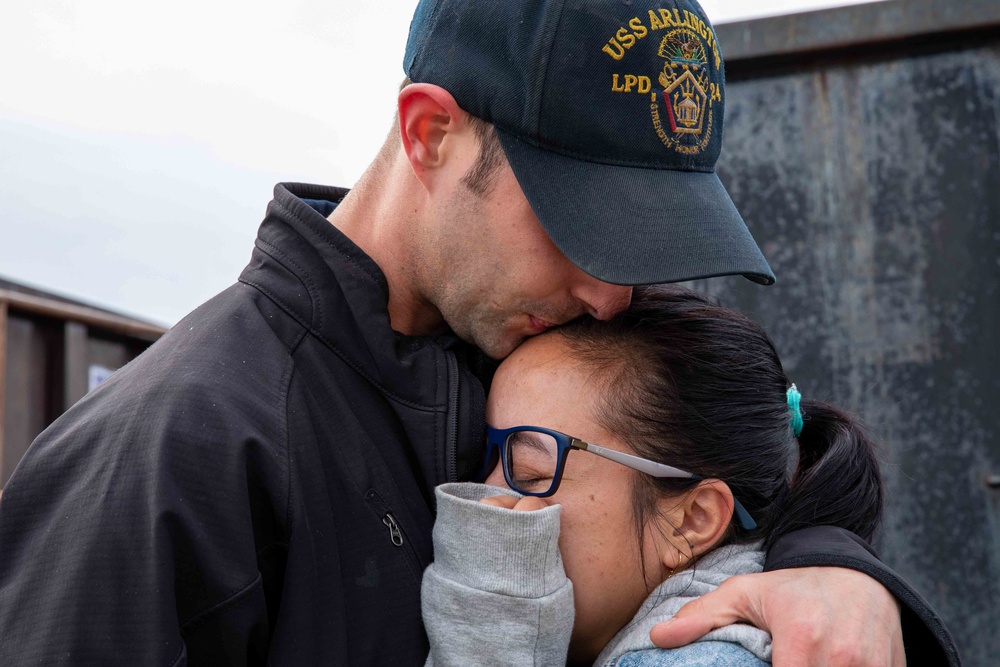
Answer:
[{"left": 0, "top": 185, "right": 950, "bottom": 665}]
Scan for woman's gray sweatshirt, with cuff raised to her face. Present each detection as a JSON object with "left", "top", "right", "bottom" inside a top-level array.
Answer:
[{"left": 421, "top": 483, "right": 771, "bottom": 667}]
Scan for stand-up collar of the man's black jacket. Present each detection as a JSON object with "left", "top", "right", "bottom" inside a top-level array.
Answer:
[{"left": 241, "top": 183, "right": 470, "bottom": 409}]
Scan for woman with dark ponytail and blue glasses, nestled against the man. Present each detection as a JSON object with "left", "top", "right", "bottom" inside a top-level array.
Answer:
[{"left": 423, "top": 288, "right": 883, "bottom": 667}]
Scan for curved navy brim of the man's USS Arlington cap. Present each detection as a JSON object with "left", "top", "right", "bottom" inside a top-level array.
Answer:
[{"left": 497, "top": 128, "right": 774, "bottom": 285}]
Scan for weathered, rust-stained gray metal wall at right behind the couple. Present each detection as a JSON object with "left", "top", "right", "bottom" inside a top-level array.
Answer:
[{"left": 697, "top": 0, "right": 1000, "bottom": 666}]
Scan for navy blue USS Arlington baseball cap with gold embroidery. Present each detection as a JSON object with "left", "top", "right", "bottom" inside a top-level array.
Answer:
[{"left": 403, "top": 0, "right": 774, "bottom": 285}]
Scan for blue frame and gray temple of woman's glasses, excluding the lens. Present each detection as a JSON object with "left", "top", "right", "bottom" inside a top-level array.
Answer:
[{"left": 479, "top": 424, "right": 757, "bottom": 530}]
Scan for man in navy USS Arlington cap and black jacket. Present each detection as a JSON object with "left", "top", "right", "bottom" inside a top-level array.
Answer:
[{"left": 0, "top": 0, "right": 950, "bottom": 665}]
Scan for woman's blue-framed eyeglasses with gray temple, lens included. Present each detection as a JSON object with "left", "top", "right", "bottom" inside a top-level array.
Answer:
[{"left": 480, "top": 425, "right": 757, "bottom": 530}]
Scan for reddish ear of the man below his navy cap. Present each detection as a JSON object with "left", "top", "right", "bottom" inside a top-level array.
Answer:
[{"left": 398, "top": 83, "right": 478, "bottom": 190}]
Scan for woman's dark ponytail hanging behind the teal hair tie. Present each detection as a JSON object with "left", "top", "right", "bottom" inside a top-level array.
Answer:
[{"left": 766, "top": 399, "right": 884, "bottom": 548}]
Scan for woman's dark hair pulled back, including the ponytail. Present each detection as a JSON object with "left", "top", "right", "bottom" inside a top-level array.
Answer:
[{"left": 558, "top": 287, "right": 883, "bottom": 548}]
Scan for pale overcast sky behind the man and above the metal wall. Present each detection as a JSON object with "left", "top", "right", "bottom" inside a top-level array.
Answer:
[{"left": 0, "top": 0, "right": 888, "bottom": 325}]
